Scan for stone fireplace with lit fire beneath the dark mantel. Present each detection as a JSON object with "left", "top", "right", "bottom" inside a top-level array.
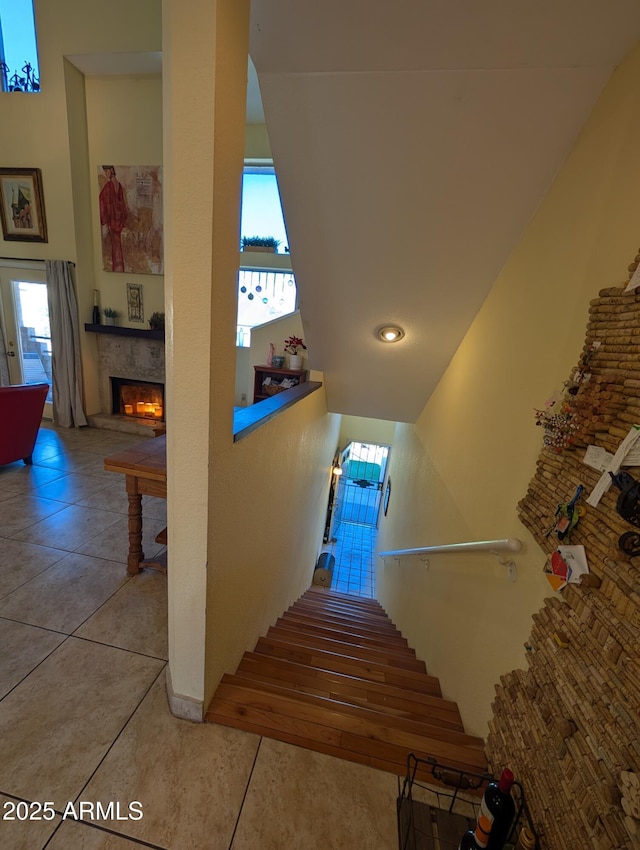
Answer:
[{"left": 88, "top": 327, "right": 165, "bottom": 435}]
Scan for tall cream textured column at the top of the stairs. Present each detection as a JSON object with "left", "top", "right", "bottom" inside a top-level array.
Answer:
[{"left": 163, "top": 0, "right": 248, "bottom": 720}]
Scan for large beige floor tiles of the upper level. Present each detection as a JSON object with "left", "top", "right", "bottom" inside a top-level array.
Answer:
[{"left": 0, "top": 426, "right": 398, "bottom": 850}]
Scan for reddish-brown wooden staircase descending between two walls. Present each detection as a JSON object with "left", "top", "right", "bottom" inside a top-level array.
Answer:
[{"left": 205, "top": 587, "right": 487, "bottom": 776}]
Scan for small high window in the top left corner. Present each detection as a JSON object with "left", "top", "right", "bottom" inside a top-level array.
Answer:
[{"left": 0, "top": 0, "right": 40, "bottom": 92}]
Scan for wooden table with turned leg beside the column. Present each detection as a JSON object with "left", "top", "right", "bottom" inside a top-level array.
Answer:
[{"left": 104, "top": 436, "right": 167, "bottom": 575}]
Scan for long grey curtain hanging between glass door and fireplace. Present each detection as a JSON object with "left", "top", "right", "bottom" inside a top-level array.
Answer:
[{"left": 45, "top": 260, "right": 87, "bottom": 428}]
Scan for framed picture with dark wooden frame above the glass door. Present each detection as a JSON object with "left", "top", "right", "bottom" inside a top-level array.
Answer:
[{"left": 0, "top": 168, "right": 48, "bottom": 242}]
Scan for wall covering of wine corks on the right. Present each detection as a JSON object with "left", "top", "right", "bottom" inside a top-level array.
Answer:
[{"left": 487, "top": 255, "right": 640, "bottom": 850}]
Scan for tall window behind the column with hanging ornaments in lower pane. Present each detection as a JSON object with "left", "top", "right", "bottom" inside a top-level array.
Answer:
[{"left": 236, "top": 163, "right": 296, "bottom": 348}]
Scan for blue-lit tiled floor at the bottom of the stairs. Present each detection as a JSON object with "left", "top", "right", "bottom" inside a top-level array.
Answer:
[{"left": 322, "top": 522, "right": 378, "bottom": 599}]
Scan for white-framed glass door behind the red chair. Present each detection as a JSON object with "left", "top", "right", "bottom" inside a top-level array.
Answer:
[{"left": 0, "top": 267, "right": 53, "bottom": 418}]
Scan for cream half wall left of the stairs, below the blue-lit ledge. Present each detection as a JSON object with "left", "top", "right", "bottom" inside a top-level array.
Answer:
[{"left": 205, "top": 388, "right": 340, "bottom": 703}]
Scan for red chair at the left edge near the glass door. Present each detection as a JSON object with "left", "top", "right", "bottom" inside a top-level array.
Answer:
[{"left": 0, "top": 384, "right": 49, "bottom": 466}]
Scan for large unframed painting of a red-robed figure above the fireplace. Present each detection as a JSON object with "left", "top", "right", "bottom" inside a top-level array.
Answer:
[{"left": 98, "top": 165, "right": 164, "bottom": 274}]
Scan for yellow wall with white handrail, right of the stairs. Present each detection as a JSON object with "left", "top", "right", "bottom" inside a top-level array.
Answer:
[{"left": 377, "top": 38, "right": 640, "bottom": 734}]
